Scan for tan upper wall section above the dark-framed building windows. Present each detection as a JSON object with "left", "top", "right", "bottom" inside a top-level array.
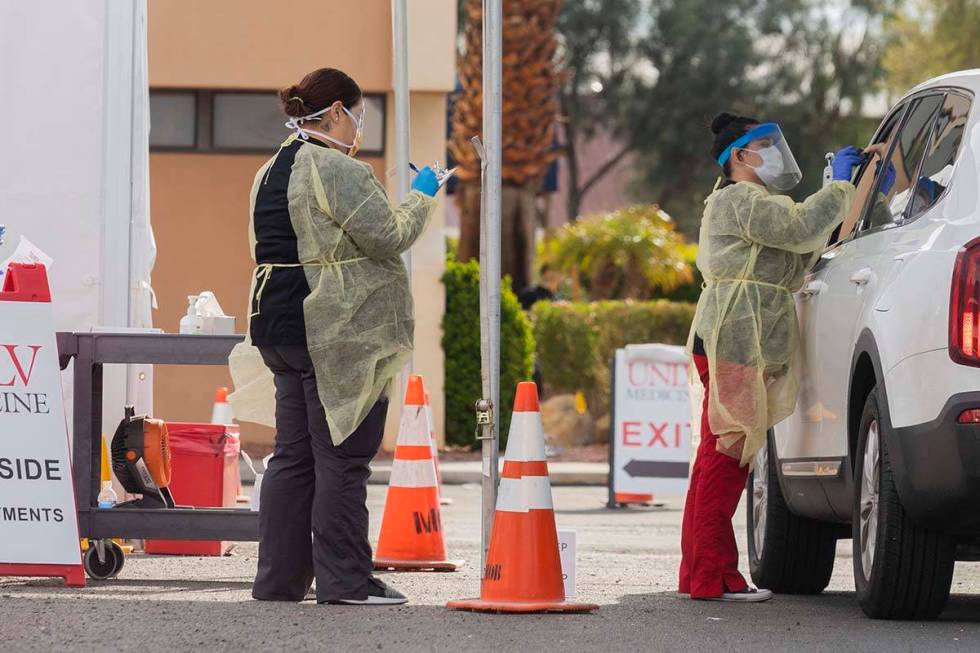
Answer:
[{"left": 147, "top": 0, "right": 391, "bottom": 92}]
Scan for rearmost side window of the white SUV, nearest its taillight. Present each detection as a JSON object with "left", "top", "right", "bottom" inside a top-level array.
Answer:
[{"left": 908, "top": 93, "right": 970, "bottom": 220}]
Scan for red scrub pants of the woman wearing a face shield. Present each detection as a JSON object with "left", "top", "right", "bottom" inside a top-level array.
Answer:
[{"left": 679, "top": 354, "right": 749, "bottom": 599}]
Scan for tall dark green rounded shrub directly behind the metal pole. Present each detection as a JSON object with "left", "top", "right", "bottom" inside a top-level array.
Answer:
[{"left": 442, "top": 260, "right": 534, "bottom": 448}]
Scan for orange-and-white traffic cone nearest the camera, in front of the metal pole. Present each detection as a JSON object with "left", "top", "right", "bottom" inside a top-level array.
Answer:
[{"left": 448, "top": 382, "right": 599, "bottom": 612}]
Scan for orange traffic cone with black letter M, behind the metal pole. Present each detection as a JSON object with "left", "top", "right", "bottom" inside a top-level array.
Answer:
[{"left": 374, "top": 375, "right": 463, "bottom": 571}]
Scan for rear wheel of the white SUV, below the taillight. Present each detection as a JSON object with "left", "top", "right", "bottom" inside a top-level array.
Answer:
[{"left": 852, "top": 390, "right": 956, "bottom": 619}]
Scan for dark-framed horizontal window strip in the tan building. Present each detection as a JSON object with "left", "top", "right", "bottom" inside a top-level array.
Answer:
[{"left": 150, "top": 89, "right": 385, "bottom": 156}]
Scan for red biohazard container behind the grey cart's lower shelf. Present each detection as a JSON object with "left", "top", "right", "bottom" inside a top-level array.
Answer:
[{"left": 143, "top": 422, "right": 241, "bottom": 556}]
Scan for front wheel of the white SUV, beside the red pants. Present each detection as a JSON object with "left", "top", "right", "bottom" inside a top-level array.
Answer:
[{"left": 746, "top": 431, "right": 839, "bottom": 594}]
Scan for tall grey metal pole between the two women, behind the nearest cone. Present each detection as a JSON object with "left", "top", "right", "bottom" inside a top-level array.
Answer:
[{"left": 480, "top": 0, "right": 503, "bottom": 568}]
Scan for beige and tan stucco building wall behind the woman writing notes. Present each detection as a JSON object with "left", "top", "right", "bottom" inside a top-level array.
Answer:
[{"left": 148, "top": 0, "right": 456, "bottom": 448}]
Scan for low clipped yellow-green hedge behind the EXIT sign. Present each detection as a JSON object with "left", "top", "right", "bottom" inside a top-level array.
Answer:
[{"left": 534, "top": 300, "right": 695, "bottom": 416}]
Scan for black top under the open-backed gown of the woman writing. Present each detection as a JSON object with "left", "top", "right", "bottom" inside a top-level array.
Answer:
[{"left": 249, "top": 138, "right": 326, "bottom": 347}]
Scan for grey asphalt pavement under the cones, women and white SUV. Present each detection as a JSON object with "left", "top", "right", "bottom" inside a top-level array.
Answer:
[{"left": 0, "top": 485, "right": 980, "bottom": 653}]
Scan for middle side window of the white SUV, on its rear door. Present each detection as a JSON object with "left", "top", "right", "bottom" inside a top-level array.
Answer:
[{"left": 861, "top": 95, "right": 943, "bottom": 230}]
